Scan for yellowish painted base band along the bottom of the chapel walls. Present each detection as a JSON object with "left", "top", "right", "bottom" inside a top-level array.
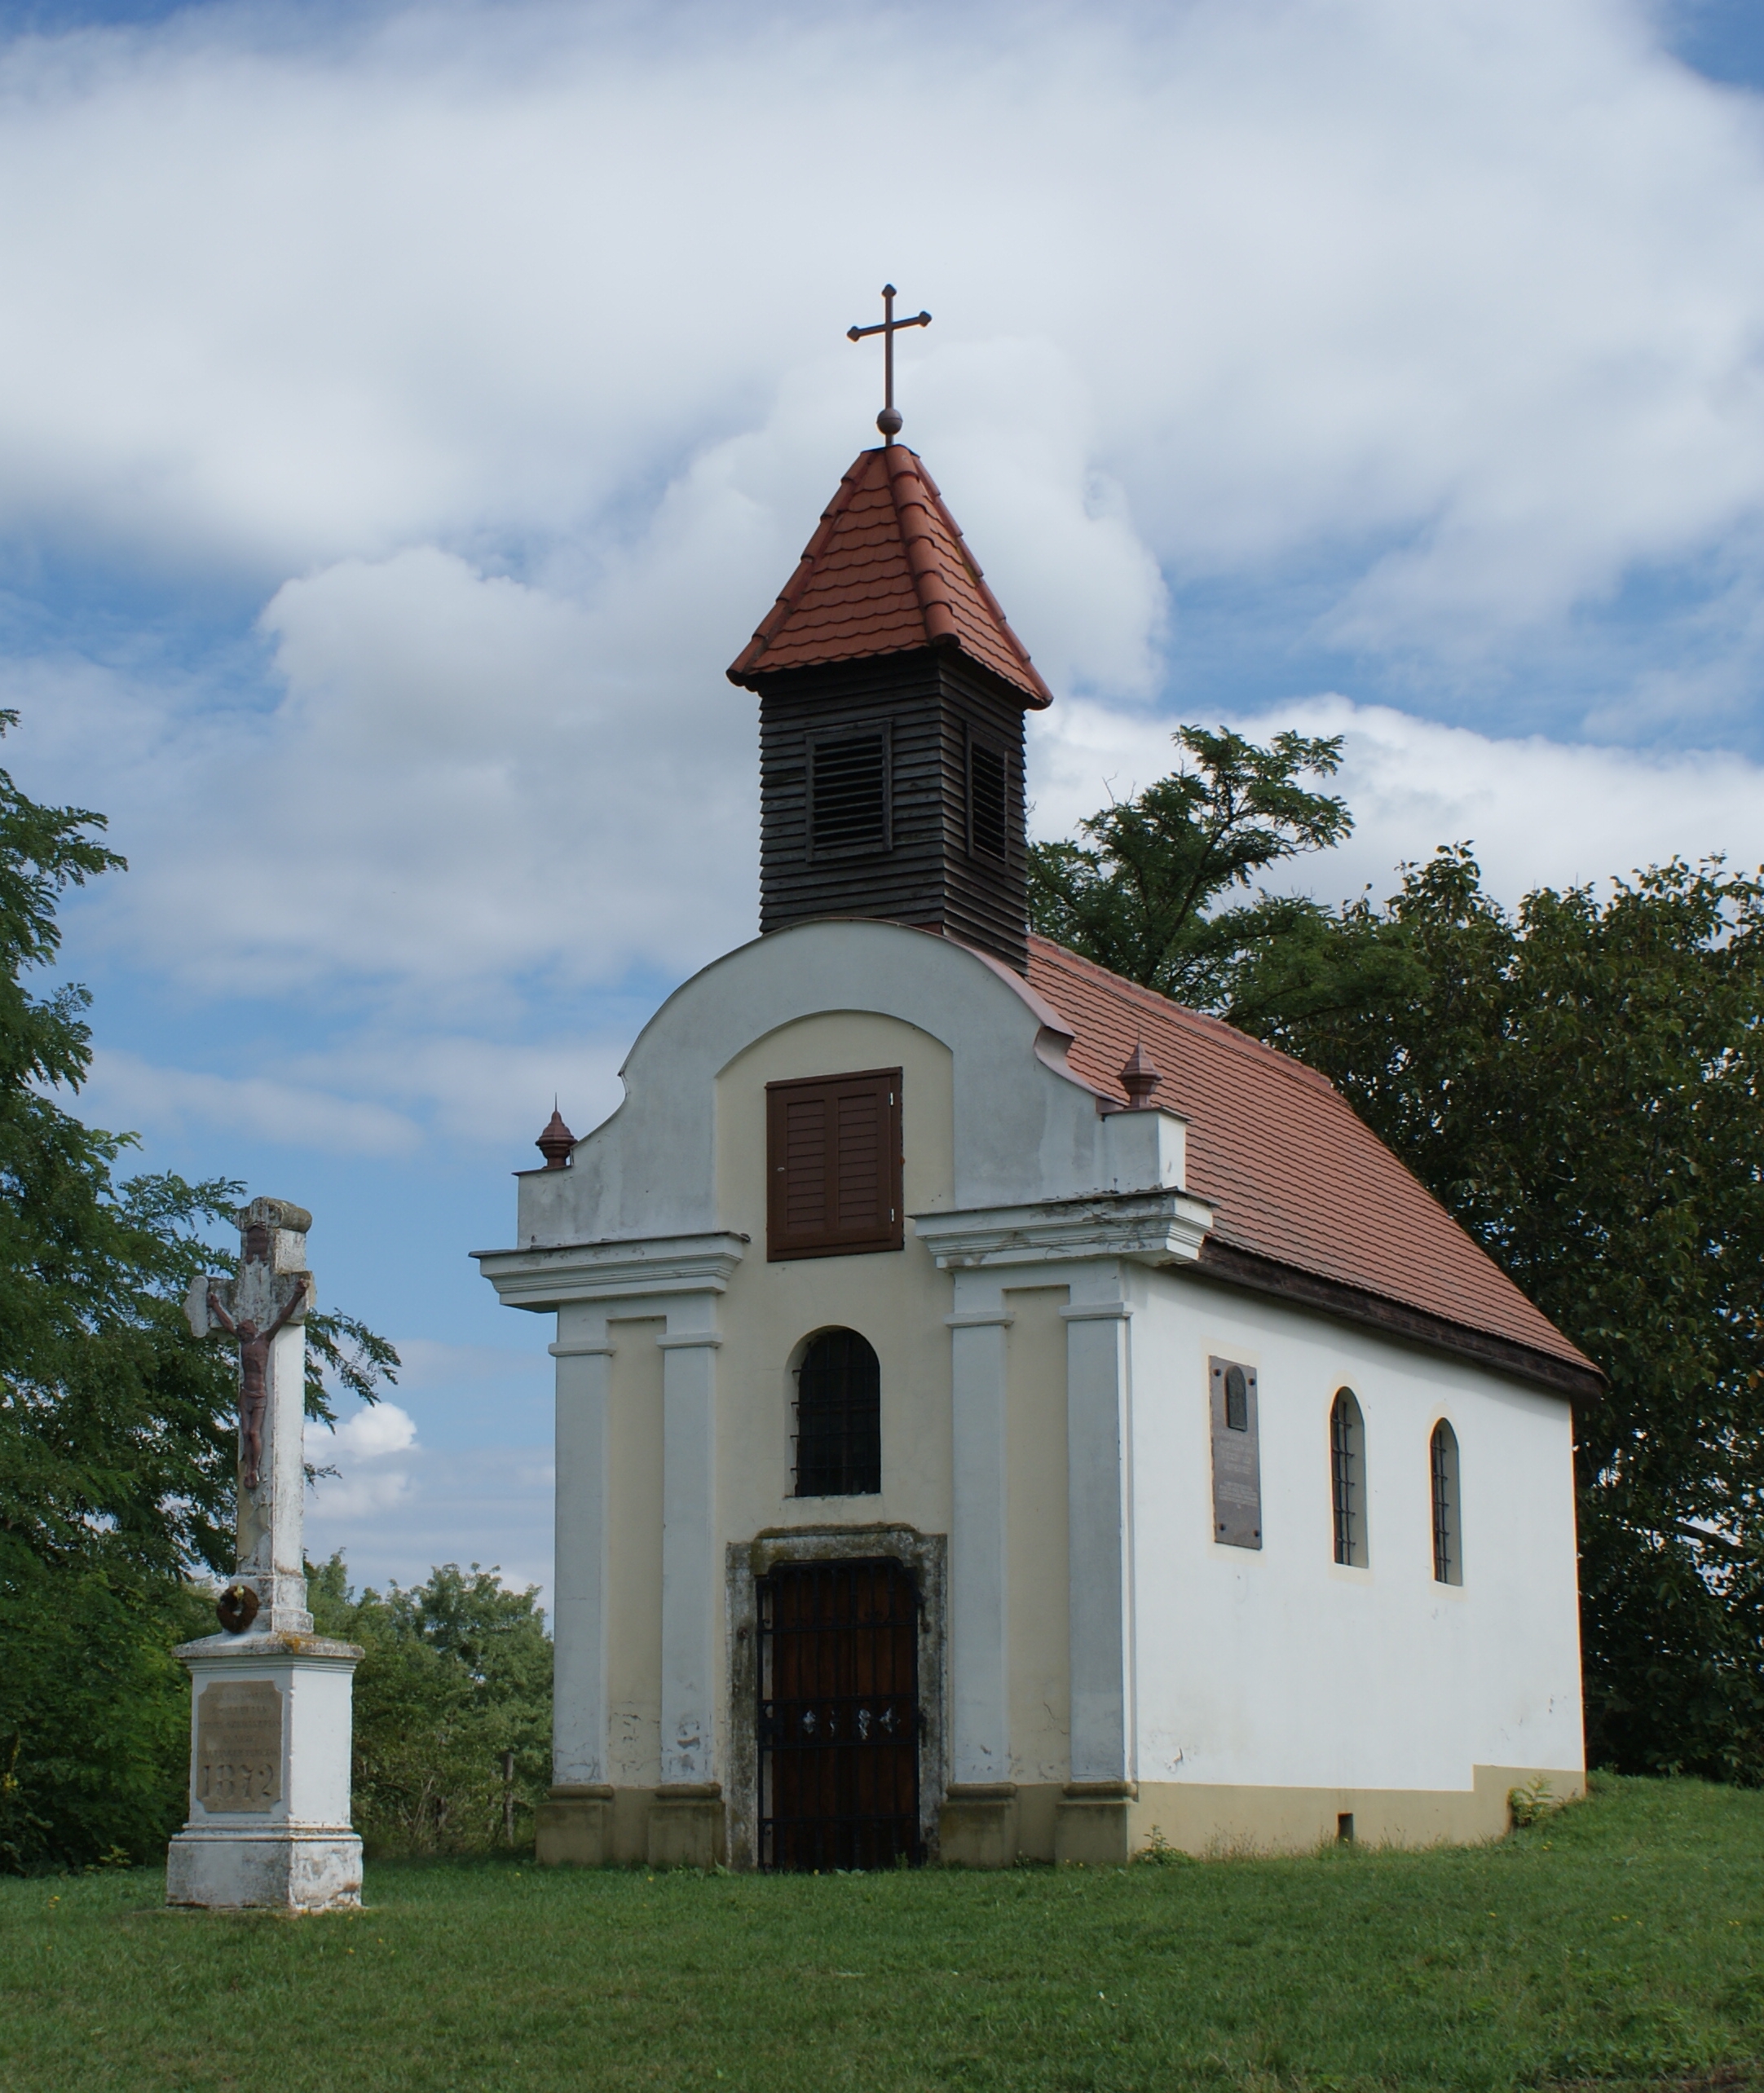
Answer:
[{"left": 538, "top": 1766, "right": 1586, "bottom": 1867}]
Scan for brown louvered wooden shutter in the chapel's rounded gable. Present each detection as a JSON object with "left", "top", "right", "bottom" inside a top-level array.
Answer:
[{"left": 766, "top": 1068, "right": 906, "bottom": 1262}]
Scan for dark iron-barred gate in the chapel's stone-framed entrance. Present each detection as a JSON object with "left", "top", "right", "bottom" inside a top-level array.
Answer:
[{"left": 757, "top": 1559, "right": 920, "bottom": 1869}]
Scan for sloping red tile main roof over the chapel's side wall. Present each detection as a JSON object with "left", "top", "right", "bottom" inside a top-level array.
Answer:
[{"left": 1030, "top": 936, "right": 1597, "bottom": 1392}]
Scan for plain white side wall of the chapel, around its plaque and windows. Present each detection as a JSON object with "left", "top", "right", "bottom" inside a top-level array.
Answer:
[{"left": 1132, "top": 1275, "right": 1582, "bottom": 1790}]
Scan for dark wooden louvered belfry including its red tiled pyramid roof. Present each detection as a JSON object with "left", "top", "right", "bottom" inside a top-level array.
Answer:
[{"left": 728, "top": 443, "right": 1051, "bottom": 973}]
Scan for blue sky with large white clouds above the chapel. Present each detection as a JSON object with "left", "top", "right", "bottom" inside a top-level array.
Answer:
[{"left": 13, "top": 0, "right": 1764, "bottom": 1582}]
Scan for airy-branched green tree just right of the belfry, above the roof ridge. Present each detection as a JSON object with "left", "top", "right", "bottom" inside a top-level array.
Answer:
[{"left": 1030, "top": 726, "right": 1354, "bottom": 1007}]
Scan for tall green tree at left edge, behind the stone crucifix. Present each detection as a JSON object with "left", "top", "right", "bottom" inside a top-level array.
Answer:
[{"left": 0, "top": 712, "right": 395, "bottom": 1867}]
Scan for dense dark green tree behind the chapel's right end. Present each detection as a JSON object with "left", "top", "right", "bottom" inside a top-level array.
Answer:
[{"left": 1228, "top": 848, "right": 1764, "bottom": 1781}]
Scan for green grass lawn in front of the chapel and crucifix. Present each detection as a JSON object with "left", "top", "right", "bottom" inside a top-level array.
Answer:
[{"left": 0, "top": 1779, "right": 1764, "bottom": 2093}]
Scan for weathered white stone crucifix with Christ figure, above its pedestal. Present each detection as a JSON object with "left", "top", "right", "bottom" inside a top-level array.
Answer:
[{"left": 184, "top": 1199, "right": 314, "bottom": 1635}]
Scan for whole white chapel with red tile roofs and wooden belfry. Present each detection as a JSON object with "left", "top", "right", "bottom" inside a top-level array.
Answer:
[{"left": 479, "top": 372, "right": 1601, "bottom": 1869}]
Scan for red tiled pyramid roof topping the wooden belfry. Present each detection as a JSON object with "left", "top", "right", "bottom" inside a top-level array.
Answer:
[{"left": 728, "top": 443, "right": 1052, "bottom": 710}]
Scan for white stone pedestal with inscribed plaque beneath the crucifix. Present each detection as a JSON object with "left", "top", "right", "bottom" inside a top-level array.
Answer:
[{"left": 165, "top": 1635, "right": 362, "bottom": 1911}]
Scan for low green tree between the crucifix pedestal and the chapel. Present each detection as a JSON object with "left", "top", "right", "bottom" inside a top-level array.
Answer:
[{"left": 310, "top": 1555, "right": 553, "bottom": 1853}]
